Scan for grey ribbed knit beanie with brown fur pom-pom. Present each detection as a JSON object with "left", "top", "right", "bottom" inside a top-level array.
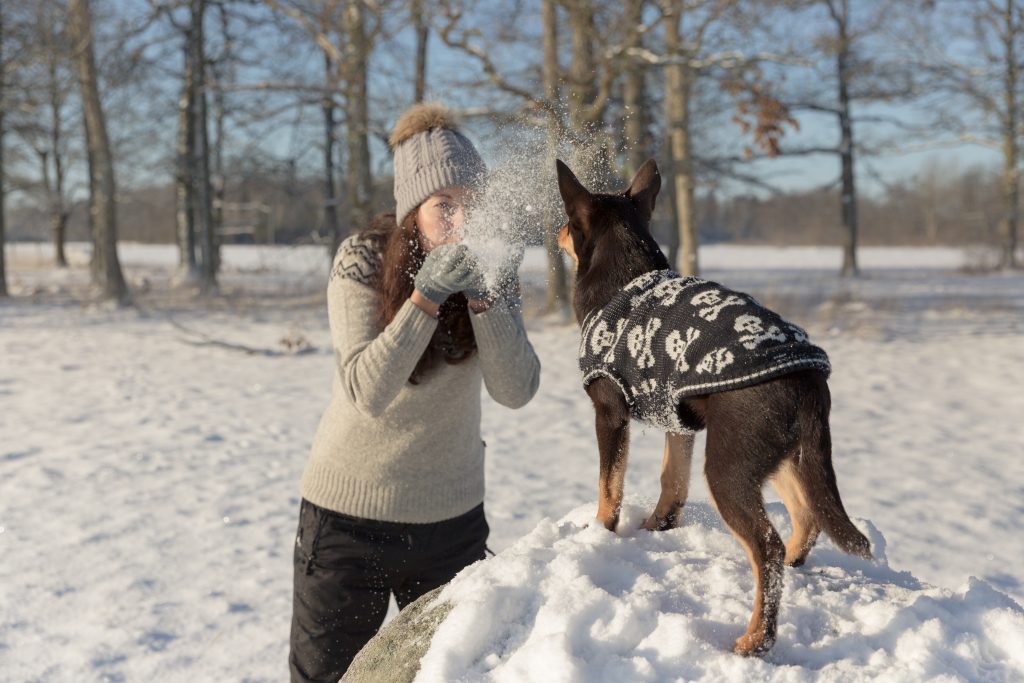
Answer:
[{"left": 388, "top": 102, "right": 487, "bottom": 224}]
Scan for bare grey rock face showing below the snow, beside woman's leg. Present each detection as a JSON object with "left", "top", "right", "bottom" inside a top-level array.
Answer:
[{"left": 341, "top": 586, "right": 452, "bottom": 683}]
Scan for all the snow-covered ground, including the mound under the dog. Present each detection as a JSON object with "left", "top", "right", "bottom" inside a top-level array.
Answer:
[{"left": 0, "top": 245, "right": 1024, "bottom": 683}]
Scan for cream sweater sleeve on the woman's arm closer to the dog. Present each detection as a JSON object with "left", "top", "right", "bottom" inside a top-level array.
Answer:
[{"left": 470, "top": 299, "right": 541, "bottom": 409}]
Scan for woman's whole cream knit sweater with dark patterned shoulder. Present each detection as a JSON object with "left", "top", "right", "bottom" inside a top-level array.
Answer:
[{"left": 300, "top": 236, "right": 541, "bottom": 523}]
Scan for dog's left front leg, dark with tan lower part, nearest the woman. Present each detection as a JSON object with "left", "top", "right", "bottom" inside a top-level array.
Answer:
[{"left": 587, "top": 378, "right": 630, "bottom": 531}]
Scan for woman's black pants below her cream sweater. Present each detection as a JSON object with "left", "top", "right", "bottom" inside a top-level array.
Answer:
[{"left": 288, "top": 500, "right": 490, "bottom": 683}]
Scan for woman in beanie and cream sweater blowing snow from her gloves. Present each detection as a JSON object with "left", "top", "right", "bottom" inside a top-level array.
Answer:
[{"left": 289, "top": 104, "right": 541, "bottom": 682}]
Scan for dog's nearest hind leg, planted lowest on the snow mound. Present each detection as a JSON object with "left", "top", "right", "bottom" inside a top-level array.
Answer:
[{"left": 705, "top": 440, "right": 785, "bottom": 655}]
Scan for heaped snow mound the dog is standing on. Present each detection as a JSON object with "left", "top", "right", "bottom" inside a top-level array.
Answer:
[{"left": 416, "top": 502, "right": 1024, "bottom": 683}]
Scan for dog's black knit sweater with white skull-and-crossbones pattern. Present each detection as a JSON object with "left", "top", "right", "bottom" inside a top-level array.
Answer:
[{"left": 580, "top": 270, "right": 831, "bottom": 432}]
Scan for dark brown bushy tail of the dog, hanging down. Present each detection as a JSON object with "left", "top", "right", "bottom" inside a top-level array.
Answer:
[{"left": 797, "top": 377, "right": 871, "bottom": 559}]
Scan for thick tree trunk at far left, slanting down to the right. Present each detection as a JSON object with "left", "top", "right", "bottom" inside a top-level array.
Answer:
[{"left": 68, "top": 0, "right": 129, "bottom": 304}]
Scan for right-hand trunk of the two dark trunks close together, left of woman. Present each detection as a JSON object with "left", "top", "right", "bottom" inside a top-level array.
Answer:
[{"left": 188, "top": 0, "right": 217, "bottom": 295}]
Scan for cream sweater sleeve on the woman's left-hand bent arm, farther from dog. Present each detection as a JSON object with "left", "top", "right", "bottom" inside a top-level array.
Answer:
[{"left": 328, "top": 237, "right": 437, "bottom": 417}]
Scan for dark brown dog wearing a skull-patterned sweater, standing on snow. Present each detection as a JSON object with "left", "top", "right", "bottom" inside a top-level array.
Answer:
[{"left": 556, "top": 160, "right": 871, "bottom": 655}]
